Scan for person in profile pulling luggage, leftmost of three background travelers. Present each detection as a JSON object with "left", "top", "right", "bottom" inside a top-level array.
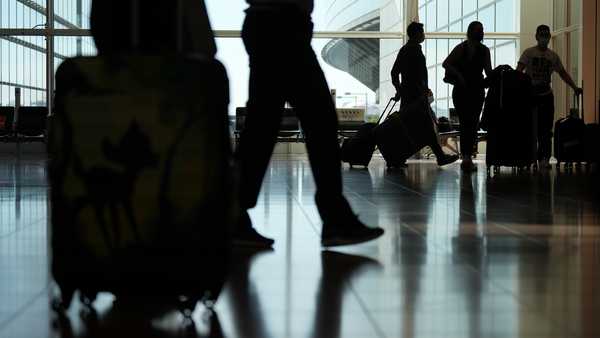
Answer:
[{"left": 391, "top": 22, "right": 458, "bottom": 166}]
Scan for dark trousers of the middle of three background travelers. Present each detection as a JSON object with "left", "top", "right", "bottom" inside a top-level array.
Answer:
[{"left": 452, "top": 86, "right": 485, "bottom": 159}]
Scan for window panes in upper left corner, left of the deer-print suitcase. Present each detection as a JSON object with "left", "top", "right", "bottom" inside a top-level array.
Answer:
[{"left": 0, "top": 0, "right": 95, "bottom": 106}]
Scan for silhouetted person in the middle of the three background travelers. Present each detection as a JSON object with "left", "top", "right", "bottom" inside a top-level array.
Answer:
[{"left": 443, "top": 21, "right": 492, "bottom": 171}]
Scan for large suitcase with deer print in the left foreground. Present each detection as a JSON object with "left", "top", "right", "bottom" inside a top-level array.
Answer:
[{"left": 48, "top": 1, "right": 231, "bottom": 314}]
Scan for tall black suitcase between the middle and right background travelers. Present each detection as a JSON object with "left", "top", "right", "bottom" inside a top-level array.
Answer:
[{"left": 483, "top": 65, "right": 537, "bottom": 170}]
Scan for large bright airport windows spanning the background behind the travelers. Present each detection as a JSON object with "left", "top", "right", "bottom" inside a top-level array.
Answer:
[{"left": 0, "top": 0, "right": 520, "bottom": 120}]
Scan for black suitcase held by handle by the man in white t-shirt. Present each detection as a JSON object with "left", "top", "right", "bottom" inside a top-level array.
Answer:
[{"left": 554, "top": 95, "right": 586, "bottom": 169}]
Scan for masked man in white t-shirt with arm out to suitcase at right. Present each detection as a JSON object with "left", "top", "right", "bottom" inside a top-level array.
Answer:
[{"left": 517, "top": 25, "right": 583, "bottom": 169}]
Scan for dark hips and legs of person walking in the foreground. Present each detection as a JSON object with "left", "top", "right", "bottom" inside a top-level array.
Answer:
[{"left": 233, "top": 0, "right": 383, "bottom": 248}]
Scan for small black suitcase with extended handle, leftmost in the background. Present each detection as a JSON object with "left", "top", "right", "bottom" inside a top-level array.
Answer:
[{"left": 342, "top": 99, "right": 396, "bottom": 167}]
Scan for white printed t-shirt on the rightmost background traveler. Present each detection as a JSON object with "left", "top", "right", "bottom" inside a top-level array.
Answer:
[{"left": 519, "top": 46, "right": 564, "bottom": 95}]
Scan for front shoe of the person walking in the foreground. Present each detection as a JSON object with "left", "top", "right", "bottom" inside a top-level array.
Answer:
[{"left": 321, "top": 217, "right": 384, "bottom": 248}]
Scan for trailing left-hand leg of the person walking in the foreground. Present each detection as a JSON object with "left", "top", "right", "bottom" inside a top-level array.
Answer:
[{"left": 234, "top": 10, "right": 285, "bottom": 247}]
